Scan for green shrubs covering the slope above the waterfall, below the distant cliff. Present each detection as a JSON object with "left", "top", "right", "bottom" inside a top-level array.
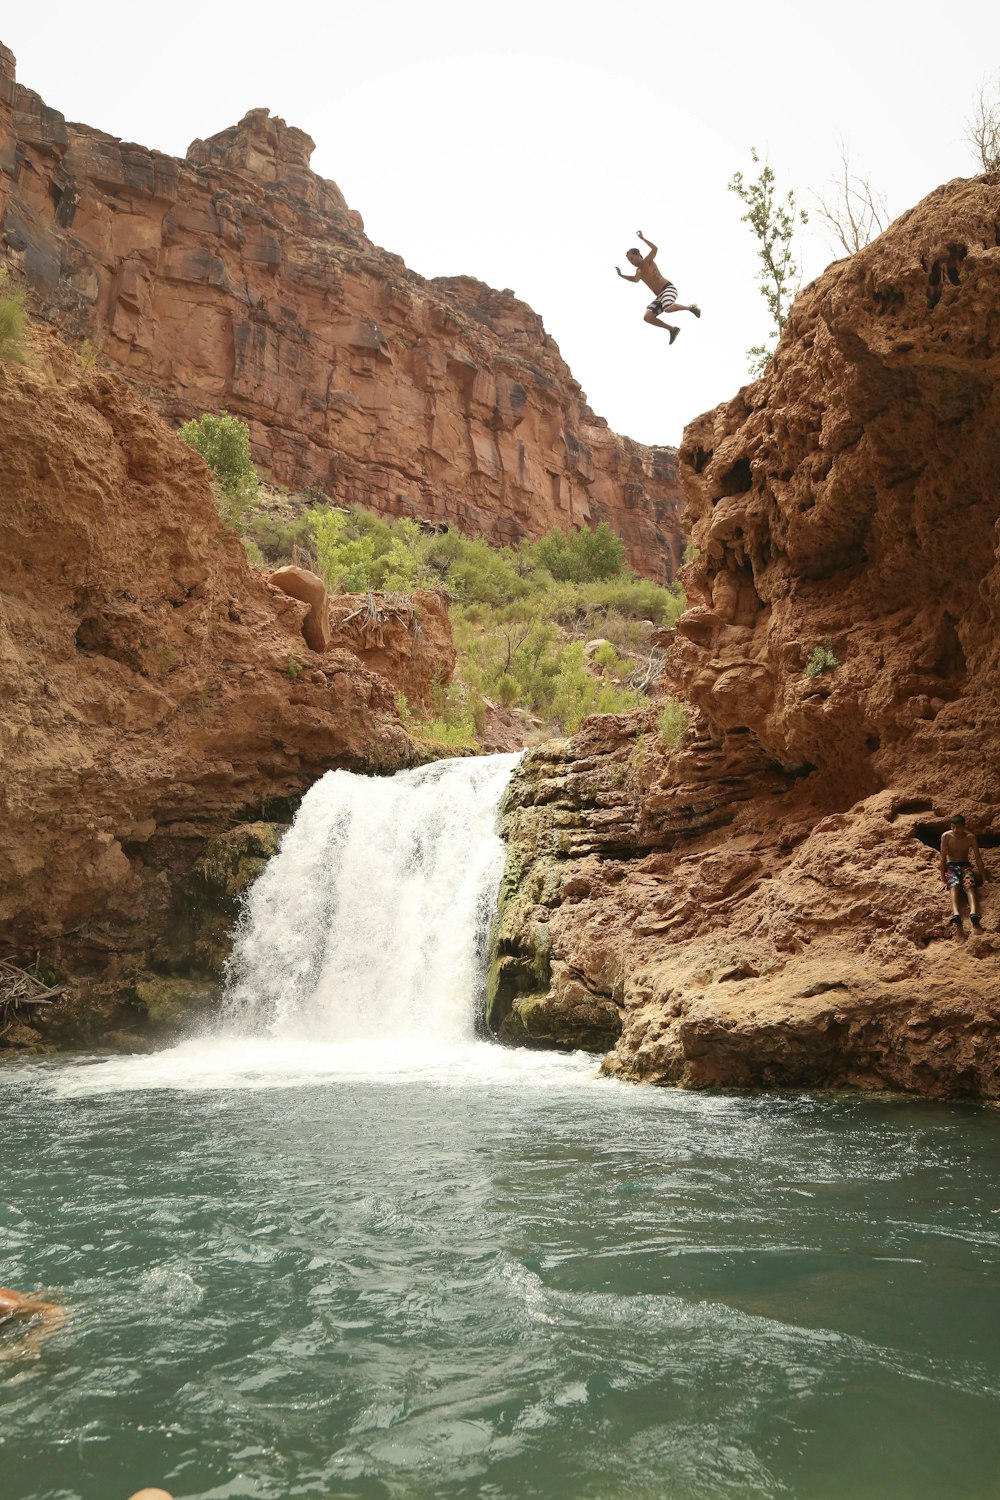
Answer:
[{"left": 241, "top": 497, "right": 684, "bottom": 752}]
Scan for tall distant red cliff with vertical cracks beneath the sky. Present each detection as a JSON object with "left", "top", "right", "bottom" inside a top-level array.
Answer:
[{"left": 0, "top": 47, "right": 684, "bottom": 581}]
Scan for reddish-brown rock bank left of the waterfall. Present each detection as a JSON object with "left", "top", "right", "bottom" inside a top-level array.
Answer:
[{"left": 0, "top": 332, "right": 454, "bottom": 1032}]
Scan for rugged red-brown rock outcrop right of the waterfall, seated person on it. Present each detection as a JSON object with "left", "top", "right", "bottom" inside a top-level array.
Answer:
[{"left": 492, "top": 176, "right": 1000, "bottom": 1098}]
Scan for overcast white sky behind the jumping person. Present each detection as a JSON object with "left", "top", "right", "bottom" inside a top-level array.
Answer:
[{"left": 0, "top": 0, "right": 1000, "bottom": 444}]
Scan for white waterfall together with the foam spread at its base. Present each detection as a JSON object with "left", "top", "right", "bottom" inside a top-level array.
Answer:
[{"left": 33, "top": 755, "right": 602, "bottom": 1098}]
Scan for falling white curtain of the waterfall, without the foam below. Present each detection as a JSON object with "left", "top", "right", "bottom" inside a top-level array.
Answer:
[{"left": 225, "top": 755, "right": 519, "bottom": 1046}]
